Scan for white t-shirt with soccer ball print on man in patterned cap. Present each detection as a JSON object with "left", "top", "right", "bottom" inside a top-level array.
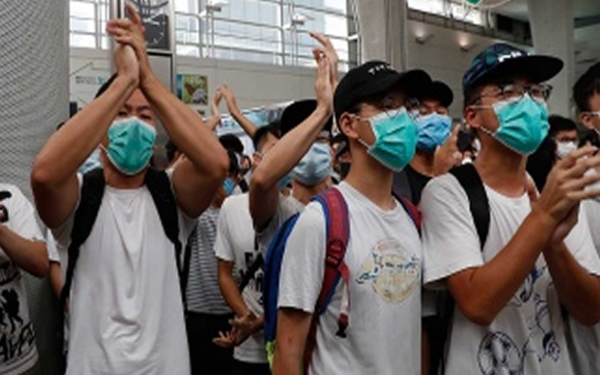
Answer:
[{"left": 421, "top": 174, "right": 600, "bottom": 375}]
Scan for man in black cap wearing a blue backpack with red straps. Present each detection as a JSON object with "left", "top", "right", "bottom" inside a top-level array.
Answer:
[{"left": 273, "top": 61, "right": 429, "bottom": 375}]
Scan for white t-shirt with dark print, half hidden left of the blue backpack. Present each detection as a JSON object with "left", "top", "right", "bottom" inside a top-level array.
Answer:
[{"left": 215, "top": 193, "right": 267, "bottom": 363}]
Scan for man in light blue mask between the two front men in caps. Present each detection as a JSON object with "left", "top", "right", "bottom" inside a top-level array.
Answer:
[{"left": 393, "top": 81, "right": 460, "bottom": 205}]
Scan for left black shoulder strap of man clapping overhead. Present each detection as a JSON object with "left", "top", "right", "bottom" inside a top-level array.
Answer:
[{"left": 60, "top": 168, "right": 105, "bottom": 307}]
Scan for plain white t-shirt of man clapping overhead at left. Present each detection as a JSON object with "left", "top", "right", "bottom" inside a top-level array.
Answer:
[{"left": 53, "top": 175, "right": 195, "bottom": 375}]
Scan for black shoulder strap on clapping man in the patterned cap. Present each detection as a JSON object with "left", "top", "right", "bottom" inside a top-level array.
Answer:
[{"left": 450, "top": 163, "right": 490, "bottom": 251}]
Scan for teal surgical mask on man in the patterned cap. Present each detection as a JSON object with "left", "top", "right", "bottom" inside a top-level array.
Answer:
[{"left": 481, "top": 94, "right": 550, "bottom": 155}]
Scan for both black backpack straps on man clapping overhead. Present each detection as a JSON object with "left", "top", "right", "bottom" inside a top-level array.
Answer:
[{"left": 60, "top": 168, "right": 186, "bottom": 315}]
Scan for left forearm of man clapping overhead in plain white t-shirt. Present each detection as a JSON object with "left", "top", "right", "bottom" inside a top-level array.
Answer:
[{"left": 32, "top": 76, "right": 136, "bottom": 185}]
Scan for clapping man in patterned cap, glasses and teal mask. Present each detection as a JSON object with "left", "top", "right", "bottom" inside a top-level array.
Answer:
[{"left": 421, "top": 44, "right": 600, "bottom": 375}]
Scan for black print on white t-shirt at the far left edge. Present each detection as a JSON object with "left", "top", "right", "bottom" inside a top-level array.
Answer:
[{"left": 0, "top": 262, "right": 35, "bottom": 365}]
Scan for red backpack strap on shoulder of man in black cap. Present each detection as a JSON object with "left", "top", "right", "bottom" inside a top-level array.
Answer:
[{"left": 304, "top": 188, "right": 350, "bottom": 372}]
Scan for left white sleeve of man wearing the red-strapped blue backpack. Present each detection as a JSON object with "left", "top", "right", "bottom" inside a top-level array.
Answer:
[{"left": 277, "top": 202, "right": 326, "bottom": 313}]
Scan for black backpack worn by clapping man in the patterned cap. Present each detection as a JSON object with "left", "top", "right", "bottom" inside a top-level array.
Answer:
[{"left": 429, "top": 163, "right": 490, "bottom": 375}]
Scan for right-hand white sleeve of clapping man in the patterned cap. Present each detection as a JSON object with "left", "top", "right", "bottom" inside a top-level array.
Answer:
[{"left": 565, "top": 209, "right": 600, "bottom": 276}]
